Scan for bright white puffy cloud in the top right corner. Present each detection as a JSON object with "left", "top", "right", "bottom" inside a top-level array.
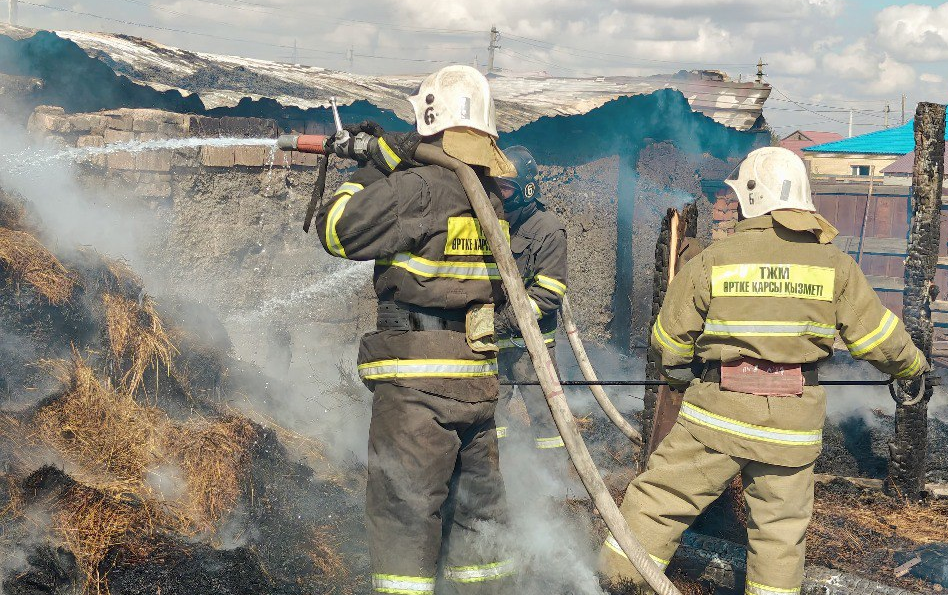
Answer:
[{"left": 875, "top": 2, "right": 948, "bottom": 62}]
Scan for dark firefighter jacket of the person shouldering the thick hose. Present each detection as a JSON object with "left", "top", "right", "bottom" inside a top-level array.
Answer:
[{"left": 316, "top": 149, "right": 506, "bottom": 402}]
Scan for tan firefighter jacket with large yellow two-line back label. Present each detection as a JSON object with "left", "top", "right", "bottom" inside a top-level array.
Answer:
[{"left": 651, "top": 210, "right": 929, "bottom": 467}]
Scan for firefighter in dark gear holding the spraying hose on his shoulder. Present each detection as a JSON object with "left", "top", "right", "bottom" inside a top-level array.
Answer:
[{"left": 316, "top": 66, "right": 515, "bottom": 595}]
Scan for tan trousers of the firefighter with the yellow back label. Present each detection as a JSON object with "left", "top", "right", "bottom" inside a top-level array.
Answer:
[{"left": 600, "top": 424, "right": 813, "bottom": 595}]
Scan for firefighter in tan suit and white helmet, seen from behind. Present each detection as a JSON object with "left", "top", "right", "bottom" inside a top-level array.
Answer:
[{"left": 601, "top": 147, "right": 929, "bottom": 595}]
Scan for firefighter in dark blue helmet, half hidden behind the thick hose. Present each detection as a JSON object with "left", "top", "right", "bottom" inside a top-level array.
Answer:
[{"left": 497, "top": 146, "right": 566, "bottom": 454}]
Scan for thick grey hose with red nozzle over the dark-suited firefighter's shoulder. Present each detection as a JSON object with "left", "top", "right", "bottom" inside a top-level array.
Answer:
[{"left": 277, "top": 129, "right": 681, "bottom": 595}]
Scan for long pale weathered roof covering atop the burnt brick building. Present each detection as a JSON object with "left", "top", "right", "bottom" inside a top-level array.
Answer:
[{"left": 0, "top": 26, "right": 770, "bottom": 131}]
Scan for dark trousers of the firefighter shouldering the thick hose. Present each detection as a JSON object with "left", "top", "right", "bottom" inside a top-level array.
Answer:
[{"left": 366, "top": 382, "right": 515, "bottom": 595}]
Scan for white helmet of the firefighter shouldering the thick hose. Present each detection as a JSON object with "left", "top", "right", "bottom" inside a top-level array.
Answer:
[{"left": 408, "top": 65, "right": 497, "bottom": 138}]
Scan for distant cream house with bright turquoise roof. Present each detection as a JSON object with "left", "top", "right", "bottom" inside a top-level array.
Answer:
[{"left": 803, "top": 121, "right": 948, "bottom": 177}]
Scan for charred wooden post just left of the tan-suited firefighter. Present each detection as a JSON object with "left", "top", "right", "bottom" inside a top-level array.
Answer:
[{"left": 639, "top": 203, "right": 698, "bottom": 469}]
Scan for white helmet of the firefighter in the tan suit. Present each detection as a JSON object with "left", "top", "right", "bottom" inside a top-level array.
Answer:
[{"left": 724, "top": 147, "right": 816, "bottom": 219}]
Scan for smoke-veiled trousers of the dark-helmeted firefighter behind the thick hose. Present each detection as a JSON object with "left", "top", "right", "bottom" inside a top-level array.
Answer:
[{"left": 497, "top": 345, "right": 566, "bottom": 460}]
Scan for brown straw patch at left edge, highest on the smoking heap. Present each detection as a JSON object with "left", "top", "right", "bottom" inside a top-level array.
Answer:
[{"left": 0, "top": 227, "right": 76, "bottom": 305}]
